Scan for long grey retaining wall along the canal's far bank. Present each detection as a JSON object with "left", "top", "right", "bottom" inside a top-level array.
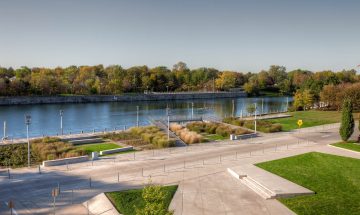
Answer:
[{"left": 0, "top": 92, "right": 247, "bottom": 106}]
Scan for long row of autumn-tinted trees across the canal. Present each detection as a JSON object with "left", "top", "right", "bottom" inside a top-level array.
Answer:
[{"left": 0, "top": 62, "right": 360, "bottom": 104}]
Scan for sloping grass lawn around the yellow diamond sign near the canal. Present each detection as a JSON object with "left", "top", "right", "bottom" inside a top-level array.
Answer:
[{"left": 266, "top": 111, "right": 346, "bottom": 131}]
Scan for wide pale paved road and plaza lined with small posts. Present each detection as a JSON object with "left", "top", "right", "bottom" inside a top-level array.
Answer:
[{"left": 0, "top": 122, "right": 358, "bottom": 214}]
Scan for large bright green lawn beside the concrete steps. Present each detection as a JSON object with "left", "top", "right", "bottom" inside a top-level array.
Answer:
[{"left": 257, "top": 152, "right": 360, "bottom": 215}]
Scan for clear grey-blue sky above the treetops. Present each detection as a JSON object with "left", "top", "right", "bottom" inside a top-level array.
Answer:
[{"left": 0, "top": 0, "right": 360, "bottom": 72}]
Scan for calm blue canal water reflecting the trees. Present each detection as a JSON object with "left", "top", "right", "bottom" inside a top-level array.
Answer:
[{"left": 0, "top": 97, "right": 292, "bottom": 138}]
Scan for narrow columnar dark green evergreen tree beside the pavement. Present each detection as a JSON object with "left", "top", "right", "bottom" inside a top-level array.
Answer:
[{"left": 340, "top": 99, "right": 355, "bottom": 141}]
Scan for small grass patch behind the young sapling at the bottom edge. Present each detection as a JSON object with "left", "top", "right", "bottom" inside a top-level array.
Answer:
[{"left": 106, "top": 185, "right": 178, "bottom": 215}]
